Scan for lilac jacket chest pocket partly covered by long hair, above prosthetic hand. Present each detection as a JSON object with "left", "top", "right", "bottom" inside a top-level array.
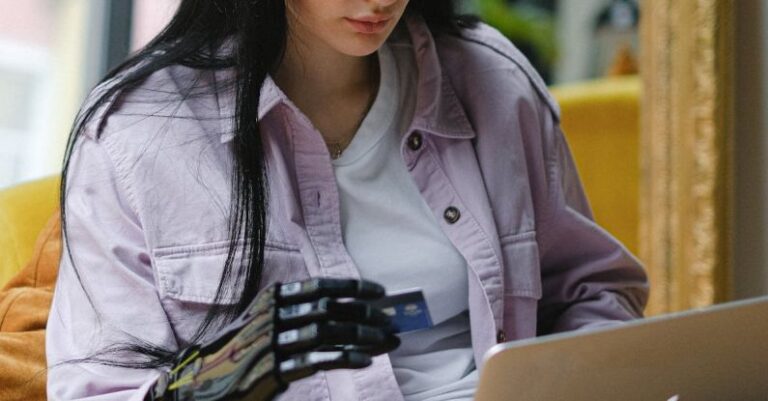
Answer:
[{"left": 154, "top": 241, "right": 308, "bottom": 344}]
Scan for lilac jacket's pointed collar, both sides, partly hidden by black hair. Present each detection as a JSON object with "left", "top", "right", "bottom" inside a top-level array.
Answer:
[{"left": 216, "top": 16, "right": 475, "bottom": 143}]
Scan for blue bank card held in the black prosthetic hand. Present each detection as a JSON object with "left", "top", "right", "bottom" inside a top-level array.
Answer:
[{"left": 371, "top": 289, "right": 433, "bottom": 333}]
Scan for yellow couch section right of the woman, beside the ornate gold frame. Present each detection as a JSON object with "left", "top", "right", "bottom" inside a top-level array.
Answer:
[{"left": 552, "top": 76, "right": 642, "bottom": 255}]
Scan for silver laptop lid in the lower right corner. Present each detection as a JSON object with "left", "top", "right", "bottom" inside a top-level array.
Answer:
[{"left": 475, "top": 297, "right": 768, "bottom": 401}]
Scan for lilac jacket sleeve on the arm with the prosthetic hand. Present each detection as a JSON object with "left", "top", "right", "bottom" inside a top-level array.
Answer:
[{"left": 46, "top": 137, "right": 177, "bottom": 401}]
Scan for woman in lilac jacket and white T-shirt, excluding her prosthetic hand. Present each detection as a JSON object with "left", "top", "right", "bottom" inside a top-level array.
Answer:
[{"left": 47, "top": 0, "right": 647, "bottom": 400}]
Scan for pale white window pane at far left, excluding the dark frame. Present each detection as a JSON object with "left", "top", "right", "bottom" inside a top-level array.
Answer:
[{"left": 0, "top": 0, "right": 60, "bottom": 186}]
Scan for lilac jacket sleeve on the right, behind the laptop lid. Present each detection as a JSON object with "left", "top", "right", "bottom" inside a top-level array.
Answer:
[{"left": 537, "top": 104, "right": 648, "bottom": 334}]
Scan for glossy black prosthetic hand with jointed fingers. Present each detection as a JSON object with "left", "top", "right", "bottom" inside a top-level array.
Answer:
[{"left": 145, "top": 279, "right": 400, "bottom": 401}]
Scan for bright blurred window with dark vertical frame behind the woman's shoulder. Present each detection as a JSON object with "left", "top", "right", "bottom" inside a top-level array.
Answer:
[{"left": 0, "top": 0, "right": 156, "bottom": 187}]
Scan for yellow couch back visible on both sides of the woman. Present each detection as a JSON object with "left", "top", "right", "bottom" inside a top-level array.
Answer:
[{"left": 0, "top": 77, "right": 640, "bottom": 287}]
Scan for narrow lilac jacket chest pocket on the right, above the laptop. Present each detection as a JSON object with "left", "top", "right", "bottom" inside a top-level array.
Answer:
[{"left": 501, "top": 231, "right": 542, "bottom": 341}]
